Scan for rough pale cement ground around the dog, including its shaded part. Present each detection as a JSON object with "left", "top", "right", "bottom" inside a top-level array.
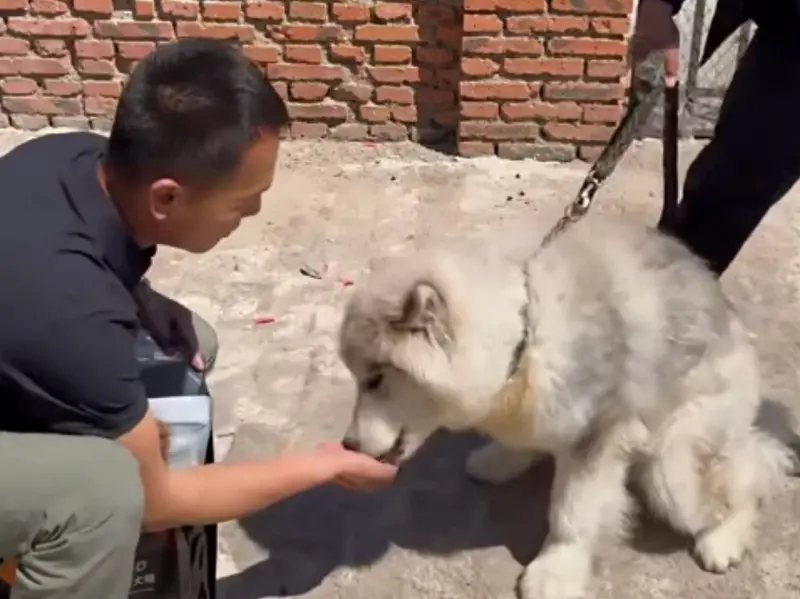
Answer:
[{"left": 0, "top": 132, "right": 800, "bottom": 599}]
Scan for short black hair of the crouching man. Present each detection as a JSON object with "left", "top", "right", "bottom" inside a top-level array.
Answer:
[{"left": 105, "top": 38, "right": 289, "bottom": 185}]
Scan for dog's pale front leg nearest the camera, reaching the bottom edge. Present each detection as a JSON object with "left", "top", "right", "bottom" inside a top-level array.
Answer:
[{"left": 517, "top": 427, "right": 630, "bottom": 599}]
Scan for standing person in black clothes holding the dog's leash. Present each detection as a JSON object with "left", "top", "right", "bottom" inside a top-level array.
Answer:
[{"left": 632, "top": 0, "right": 800, "bottom": 275}]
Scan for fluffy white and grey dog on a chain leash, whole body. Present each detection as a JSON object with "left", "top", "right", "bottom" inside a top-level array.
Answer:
[{"left": 340, "top": 216, "right": 792, "bottom": 599}]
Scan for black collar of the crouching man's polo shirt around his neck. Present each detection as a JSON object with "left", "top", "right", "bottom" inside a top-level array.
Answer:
[{"left": 61, "top": 141, "right": 156, "bottom": 291}]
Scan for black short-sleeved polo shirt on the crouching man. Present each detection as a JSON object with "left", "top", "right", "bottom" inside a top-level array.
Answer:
[{"left": 0, "top": 133, "right": 154, "bottom": 438}]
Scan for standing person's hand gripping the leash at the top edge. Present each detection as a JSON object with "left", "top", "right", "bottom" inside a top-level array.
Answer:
[{"left": 631, "top": 0, "right": 681, "bottom": 87}]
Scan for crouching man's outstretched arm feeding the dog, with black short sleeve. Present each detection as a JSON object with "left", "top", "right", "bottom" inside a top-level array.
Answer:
[{"left": 13, "top": 261, "right": 395, "bottom": 530}]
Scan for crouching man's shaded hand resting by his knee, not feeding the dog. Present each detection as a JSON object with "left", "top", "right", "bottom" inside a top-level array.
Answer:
[{"left": 136, "top": 281, "right": 205, "bottom": 372}]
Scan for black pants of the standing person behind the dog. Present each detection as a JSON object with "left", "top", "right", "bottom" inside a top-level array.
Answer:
[{"left": 669, "top": 30, "right": 800, "bottom": 275}]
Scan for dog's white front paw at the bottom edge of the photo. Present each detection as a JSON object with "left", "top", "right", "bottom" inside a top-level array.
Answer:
[{"left": 516, "top": 544, "right": 591, "bottom": 599}]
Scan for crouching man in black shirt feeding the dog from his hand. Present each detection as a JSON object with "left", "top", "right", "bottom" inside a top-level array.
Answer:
[{"left": 0, "top": 39, "right": 395, "bottom": 599}]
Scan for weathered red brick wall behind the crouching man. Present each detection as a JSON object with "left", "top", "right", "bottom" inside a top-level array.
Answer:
[{"left": 0, "top": 0, "right": 632, "bottom": 160}]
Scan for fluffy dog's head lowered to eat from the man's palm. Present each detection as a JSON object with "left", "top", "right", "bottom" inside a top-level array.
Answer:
[{"left": 339, "top": 246, "right": 526, "bottom": 463}]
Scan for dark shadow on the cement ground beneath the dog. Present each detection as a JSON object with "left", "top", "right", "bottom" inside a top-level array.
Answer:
[{"left": 219, "top": 400, "right": 800, "bottom": 599}]
